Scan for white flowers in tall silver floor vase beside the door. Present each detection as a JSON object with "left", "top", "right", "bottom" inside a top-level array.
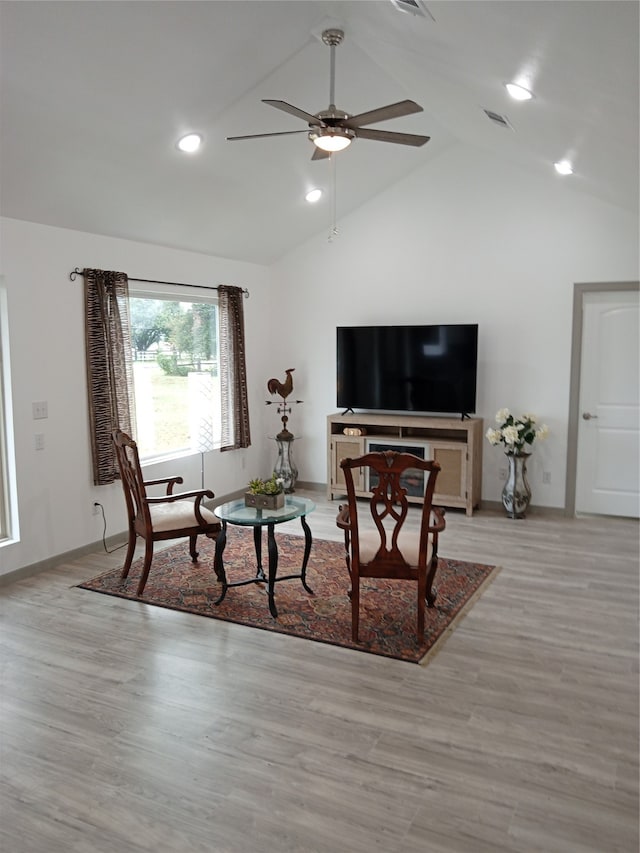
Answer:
[{"left": 486, "top": 409, "right": 549, "bottom": 518}]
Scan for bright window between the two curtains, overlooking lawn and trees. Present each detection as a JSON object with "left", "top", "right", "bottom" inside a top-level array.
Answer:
[{"left": 130, "top": 285, "right": 221, "bottom": 459}]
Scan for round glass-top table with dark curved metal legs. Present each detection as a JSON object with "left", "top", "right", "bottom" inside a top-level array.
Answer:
[{"left": 213, "top": 495, "right": 316, "bottom": 619}]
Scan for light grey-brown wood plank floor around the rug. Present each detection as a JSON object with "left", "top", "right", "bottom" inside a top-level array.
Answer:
[{"left": 0, "top": 493, "right": 638, "bottom": 853}]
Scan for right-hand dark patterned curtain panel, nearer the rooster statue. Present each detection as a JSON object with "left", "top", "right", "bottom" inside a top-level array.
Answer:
[{"left": 218, "top": 284, "right": 251, "bottom": 450}]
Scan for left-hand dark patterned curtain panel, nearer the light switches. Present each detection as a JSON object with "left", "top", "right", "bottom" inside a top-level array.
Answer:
[{"left": 83, "top": 269, "right": 136, "bottom": 486}]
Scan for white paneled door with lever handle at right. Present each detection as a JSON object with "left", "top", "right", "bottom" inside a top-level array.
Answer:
[{"left": 576, "top": 291, "right": 640, "bottom": 518}]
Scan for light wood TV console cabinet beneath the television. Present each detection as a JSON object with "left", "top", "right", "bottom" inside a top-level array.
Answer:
[{"left": 327, "top": 412, "right": 483, "bottom": 515}]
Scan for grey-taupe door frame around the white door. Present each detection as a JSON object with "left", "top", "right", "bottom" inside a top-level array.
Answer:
[{"left": 565, "top": 281, "right": 640, "bottom": 518}]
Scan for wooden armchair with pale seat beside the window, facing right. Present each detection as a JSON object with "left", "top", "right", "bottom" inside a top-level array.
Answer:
[{"left": 111, "top": 430, "right": 220, "bottom": 596}]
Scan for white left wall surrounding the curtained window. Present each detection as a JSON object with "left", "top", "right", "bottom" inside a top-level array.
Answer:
[{"left": 0, "top": 219, "right": 271, "bottom": 574}]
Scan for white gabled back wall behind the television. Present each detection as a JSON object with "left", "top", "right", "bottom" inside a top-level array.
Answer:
[{"left": 273, "top": 146, "right": 639, "bottom": 507}]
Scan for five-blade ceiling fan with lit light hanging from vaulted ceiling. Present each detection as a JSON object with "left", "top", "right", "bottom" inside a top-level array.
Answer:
[{"left": 227, "top": 29, "right": 430, "bottom": 160}]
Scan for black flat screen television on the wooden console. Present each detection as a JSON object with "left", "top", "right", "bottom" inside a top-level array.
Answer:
[{"left": 337, "top": 323, "right": 478, "bottom": 416}]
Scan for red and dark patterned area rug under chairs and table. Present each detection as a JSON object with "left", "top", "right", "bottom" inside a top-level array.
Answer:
[{"left": 78, "top": 527, "right": 497, "bottom": 663}]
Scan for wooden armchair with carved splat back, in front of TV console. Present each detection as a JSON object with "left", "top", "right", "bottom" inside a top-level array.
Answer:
[{"left": 336, "top": 450, "right": 445, "bottom": 643}]
